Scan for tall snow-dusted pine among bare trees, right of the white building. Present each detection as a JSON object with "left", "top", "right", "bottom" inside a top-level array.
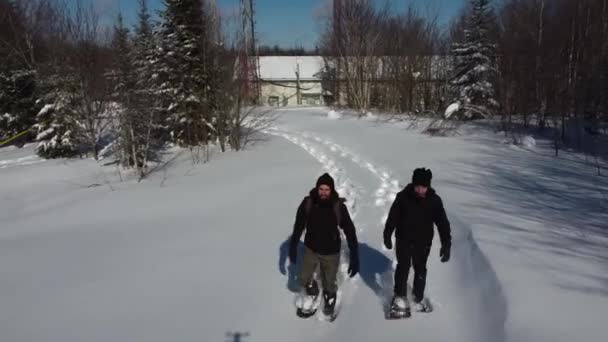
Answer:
[{"left": 451, "top": 0, "right": 499, "bottom": 120}]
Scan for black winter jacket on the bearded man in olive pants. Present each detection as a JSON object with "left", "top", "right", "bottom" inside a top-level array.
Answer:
[{"left": 290, "top": 189, "right": 358, "bottom": 255}]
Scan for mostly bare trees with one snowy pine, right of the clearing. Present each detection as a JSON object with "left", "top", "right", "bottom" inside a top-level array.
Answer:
[{"left": 320, "top": 0, "right": 608, "bottom": 137}]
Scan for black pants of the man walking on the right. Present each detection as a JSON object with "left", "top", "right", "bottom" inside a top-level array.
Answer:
[{"left": 394, "top": 241, "right": 431, "bottom": 302}]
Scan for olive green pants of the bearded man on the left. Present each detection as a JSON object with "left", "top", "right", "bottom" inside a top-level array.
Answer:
[{"left": 298, "top": 247, "right": 340, "bottom": 293}]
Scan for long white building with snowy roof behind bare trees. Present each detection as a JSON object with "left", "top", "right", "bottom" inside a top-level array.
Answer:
[{"left": 248, "top": 56, "right": 450, "bottom": 110}]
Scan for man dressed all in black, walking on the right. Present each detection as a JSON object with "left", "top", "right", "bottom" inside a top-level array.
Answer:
[{"left": 384, "top": 168, "right": 452, "bottom": 312}]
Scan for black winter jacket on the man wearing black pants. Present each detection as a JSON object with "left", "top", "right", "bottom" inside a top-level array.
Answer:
[{"left": 384, "top": 184, "right": 452, "bottom": 249}]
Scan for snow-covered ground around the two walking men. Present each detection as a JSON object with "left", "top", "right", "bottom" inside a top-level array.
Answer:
[{"left": 0, "top": 109, "right": 608, "bottom": 342}]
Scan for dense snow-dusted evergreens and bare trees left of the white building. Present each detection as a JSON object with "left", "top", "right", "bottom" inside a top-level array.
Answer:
[{"left": 0, "top": 0, "right": 262, "bottom": 176}]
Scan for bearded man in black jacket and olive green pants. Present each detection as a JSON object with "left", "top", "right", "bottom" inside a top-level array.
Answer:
[{"left": 289, "top": 173, "right": 359, "bottom": 314}]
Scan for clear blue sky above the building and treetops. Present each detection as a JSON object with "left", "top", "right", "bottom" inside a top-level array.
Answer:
[{"left": 73, "top": 0, "right": 465, "bottom": 48}]
